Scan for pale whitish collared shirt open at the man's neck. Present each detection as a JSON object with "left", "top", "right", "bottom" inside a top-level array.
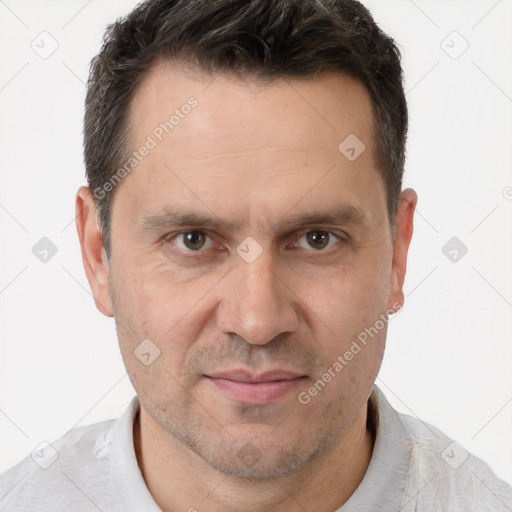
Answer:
[{"left": 0, "top": 386, "right": 512, "bottom": 512}]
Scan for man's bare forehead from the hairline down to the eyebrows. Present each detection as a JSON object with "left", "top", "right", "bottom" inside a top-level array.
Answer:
[{"left": 116, "top": 62, "right": 384, "bottom": 228}]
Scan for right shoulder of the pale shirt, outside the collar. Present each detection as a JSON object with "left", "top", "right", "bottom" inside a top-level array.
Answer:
[{"left": 397, "top": 412, "right": 512, "bottom": 512}]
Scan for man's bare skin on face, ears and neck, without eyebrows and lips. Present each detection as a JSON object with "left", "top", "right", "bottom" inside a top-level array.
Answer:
[{"left": 76, "top": 63, "right": 417, "bottom": 512}]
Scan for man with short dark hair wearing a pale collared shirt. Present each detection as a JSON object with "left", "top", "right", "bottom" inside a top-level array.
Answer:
[{"left": 1, "top": 0, "right": 512, "bottom": 512}]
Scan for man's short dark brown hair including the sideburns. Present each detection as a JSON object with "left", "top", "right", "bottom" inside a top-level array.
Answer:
[{"left": 84, "top": 0, "right": 408, "bottom": 255}]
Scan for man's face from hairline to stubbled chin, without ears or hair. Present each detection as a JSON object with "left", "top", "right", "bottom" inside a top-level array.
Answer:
[{"left": 87, "top": 64, "right": 408, "bottom": 477}]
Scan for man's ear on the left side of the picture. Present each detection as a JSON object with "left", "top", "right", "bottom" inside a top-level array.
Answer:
[{"left": 75, "top": 187, "right": 114, "bottom": 316}]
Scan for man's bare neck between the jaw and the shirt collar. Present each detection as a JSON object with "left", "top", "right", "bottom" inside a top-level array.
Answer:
[{"left": 134, "top": 404, "right": 374, "bottom": 512}]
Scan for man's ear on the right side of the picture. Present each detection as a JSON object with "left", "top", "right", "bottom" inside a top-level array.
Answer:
[{"left": 388, "top": 188, "right": 418, "bottom": 312}]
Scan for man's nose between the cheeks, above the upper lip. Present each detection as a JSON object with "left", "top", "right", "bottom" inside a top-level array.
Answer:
[{"left": 217, "top": 249, "right": 300, "bottom": 345}]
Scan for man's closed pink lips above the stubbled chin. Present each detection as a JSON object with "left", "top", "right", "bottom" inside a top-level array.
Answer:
[{"left": 204, "top": 369, "right": 307, "bottom": 405}]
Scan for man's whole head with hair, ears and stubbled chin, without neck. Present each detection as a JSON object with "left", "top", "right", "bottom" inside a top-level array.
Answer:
[{"left": 77, "top": 0, "right": 416, "bottom": 478}]
